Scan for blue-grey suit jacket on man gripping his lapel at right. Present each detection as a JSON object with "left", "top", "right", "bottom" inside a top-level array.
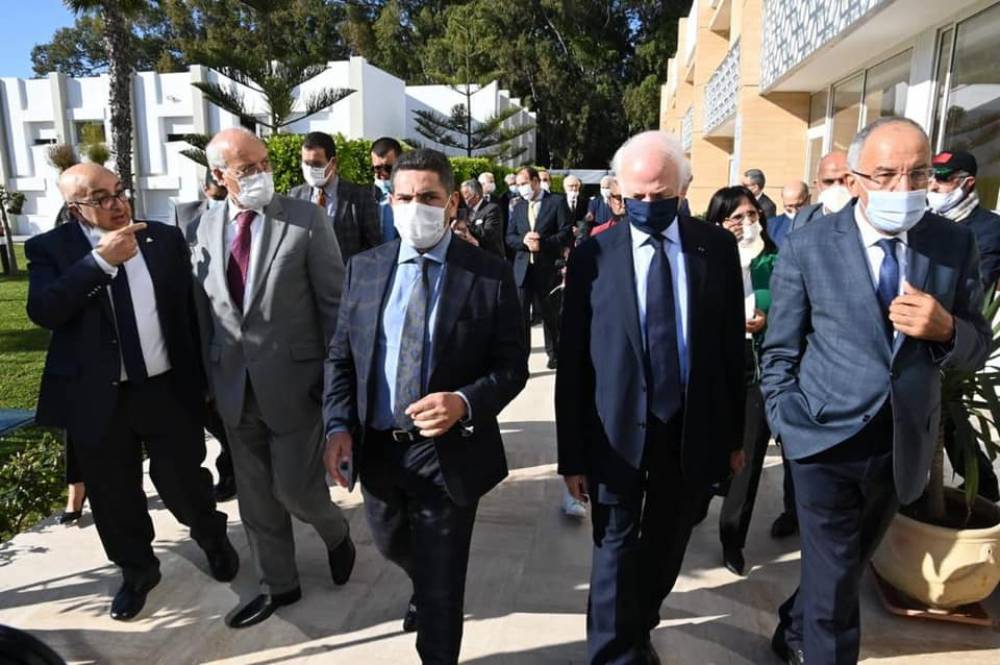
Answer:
[{"left": 761, "top": 204, "right": 991, "bottom": 504}]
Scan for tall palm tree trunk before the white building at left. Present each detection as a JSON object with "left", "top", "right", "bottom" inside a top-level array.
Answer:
[{"left": 102, "top": 2, "right": 132, "bottom": 189}]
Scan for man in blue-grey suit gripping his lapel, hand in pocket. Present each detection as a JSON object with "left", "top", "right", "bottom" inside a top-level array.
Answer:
[{"left": 761, "top": 117, "right": 991, "bottom": 665}]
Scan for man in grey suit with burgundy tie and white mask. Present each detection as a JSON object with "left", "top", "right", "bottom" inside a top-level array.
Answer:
[{"left": 192, "top": 128, "right": 354, "bottom": 628}]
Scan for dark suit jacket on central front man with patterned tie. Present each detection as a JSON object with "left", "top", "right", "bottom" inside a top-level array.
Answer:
[{"left": 323, "top": 238, "right": 528, "bottom": 505}]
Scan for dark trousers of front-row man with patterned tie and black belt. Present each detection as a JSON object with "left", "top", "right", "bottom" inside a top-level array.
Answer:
[{"left": 361, "top": 430, "right": 478, "bottom": 665}]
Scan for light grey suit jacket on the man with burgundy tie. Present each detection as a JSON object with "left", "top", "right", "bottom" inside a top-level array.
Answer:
[{"left": 191, "top": 195, "right": 344, "bottom": 433}]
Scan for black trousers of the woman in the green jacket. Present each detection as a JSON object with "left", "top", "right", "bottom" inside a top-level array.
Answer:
[{"left": 719, "top": 384, "right": 771, "bottom": 549}]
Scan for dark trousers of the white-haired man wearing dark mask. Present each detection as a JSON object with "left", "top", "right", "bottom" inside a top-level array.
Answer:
[{"left": 587, "top": 416, "right": 709, "bottom": 665}]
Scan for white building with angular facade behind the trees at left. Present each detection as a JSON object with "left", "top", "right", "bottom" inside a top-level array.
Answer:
[{"left": 0, "top": 57, "right": 535, "bottom": 235}]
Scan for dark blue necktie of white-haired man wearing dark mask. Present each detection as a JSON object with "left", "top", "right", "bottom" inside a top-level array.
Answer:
[{"left": 646, "top": 234, "right": 681, "bottom": 423}]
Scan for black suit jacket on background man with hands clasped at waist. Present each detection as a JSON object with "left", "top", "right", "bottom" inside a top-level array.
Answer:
[{"left": 507, "top": 192, "right": 573, "bottom": 286}]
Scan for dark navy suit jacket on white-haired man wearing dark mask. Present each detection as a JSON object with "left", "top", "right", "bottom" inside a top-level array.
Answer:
[{"left": 556, "top": 217, "right": 746, "bottom": 502}]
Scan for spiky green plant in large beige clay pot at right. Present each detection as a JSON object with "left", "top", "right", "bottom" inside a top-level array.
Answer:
[{"left": 872, "top": 291, "right": 1000, "bottom": 611}]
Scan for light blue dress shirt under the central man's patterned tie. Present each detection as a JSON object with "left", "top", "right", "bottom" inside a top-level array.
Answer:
[{"left": 368, "top": 231, "right": 454, "bottom": 430}]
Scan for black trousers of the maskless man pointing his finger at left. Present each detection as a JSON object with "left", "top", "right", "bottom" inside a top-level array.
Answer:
[{"left": 70, "top": 374, "right": 226, "bottom": 586}]
